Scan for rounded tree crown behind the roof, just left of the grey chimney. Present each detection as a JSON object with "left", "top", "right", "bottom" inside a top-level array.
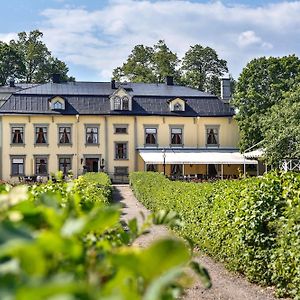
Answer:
[{"left": 181, "top": 44, "right": 228, "bottom": 95}]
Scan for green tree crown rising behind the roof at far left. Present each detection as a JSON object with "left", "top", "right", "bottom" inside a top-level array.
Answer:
[{"left": 0, "top": 30, "right": 74, "bottom": 85}]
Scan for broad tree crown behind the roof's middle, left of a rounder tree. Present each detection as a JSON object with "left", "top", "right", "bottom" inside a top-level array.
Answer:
[{"left": 113, "top": 40, "right": 179, "bottom": 83}]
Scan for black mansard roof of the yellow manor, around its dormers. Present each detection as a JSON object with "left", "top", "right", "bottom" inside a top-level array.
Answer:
[{"left": 0, "top": 82, "right": 234, "bottom": 117}]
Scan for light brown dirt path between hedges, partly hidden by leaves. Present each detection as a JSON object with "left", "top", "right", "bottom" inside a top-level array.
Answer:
[{"left": 113, "top": 185, "right": 284, "bottom": 300}]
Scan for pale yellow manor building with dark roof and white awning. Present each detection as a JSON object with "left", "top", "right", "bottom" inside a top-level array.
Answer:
[{"left": 0, "top": 76, "right": 257, "bottom": 181}]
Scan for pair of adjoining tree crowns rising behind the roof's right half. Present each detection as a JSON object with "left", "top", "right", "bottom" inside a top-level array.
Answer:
[{"left": 113, "top": 40, "right": 228, "bottom": 94}]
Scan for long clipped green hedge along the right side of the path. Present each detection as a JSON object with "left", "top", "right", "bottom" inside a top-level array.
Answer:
[{"left": 130, "top": 172, "right": 300, "bottom": 299}]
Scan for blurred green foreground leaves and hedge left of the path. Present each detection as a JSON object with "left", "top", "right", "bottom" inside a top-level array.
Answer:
[{"left": 0, "top": 174, "right": 209, "bottom": 300}]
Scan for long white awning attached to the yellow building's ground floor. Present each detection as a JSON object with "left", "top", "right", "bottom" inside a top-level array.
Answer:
[{"left": 139, "top": 149, "right": 258, "bottom": 165}]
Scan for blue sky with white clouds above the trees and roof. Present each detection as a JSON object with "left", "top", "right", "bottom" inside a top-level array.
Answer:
[{"left": 0, "top": 0, "right": 300, "bottom": 81}]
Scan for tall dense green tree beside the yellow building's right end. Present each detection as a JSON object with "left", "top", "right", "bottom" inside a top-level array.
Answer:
[{"left": 232, "top": 55, "right": 300, "bottom": 150}]
